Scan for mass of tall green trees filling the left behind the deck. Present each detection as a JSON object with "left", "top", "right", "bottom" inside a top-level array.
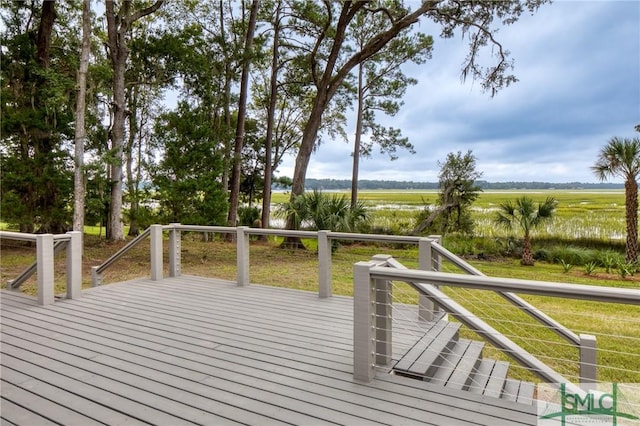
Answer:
[{"left": 0, "top": 0, "right": 545, "bottom": 240}]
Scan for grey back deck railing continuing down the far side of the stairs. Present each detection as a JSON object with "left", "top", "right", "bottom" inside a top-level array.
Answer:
[{"left": 20, "top": 223, "right": 640, "bottom": 392}]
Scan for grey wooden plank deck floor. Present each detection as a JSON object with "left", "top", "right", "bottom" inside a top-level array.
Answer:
[{"left": 0, "top": 276, "right": 536, "bottom": 426}]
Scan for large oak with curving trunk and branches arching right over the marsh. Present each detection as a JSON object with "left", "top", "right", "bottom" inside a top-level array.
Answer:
[{"left": 287, "top": 0, "right": 545, "bottom": 233}]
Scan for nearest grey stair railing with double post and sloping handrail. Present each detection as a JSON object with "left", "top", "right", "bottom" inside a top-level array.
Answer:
[{"left": 354, "top": 256, "right": 640, "bottom": 392}]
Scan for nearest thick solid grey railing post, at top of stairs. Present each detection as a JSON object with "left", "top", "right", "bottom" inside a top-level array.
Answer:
[{"left": 353, "top": 262, "right": 376, "bottom": 382}]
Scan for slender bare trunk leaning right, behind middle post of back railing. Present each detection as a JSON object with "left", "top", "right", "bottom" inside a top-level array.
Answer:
[{"left": 227, "top": 0, "right": 260, "bottom": 226}]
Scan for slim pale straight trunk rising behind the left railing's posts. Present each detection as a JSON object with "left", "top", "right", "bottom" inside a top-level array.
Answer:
[{"left": 73, "top": 0, "right": 91, "bottom": 232}]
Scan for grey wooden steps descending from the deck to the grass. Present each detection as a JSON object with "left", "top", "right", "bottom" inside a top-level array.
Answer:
[{"left": 393, "top": 320, "right": 535, "bottom": 405}]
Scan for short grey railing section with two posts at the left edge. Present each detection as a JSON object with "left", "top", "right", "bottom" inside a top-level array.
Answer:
[{"left": 0, "top": 231, "right": 82, "bottom": 305}]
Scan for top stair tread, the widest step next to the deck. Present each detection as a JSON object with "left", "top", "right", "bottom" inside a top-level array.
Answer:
[{"left": 394, "top": 321, "right": 460, "bottom": 376}]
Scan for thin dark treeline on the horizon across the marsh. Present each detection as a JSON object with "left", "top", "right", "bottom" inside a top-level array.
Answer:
[{"left": 305, "top": 179, "right": 624, "bottom": 190}]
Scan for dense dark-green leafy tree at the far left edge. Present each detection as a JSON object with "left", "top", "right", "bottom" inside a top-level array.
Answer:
[{"left": 0, "top": 1, "right": 77, "bottom": 233}]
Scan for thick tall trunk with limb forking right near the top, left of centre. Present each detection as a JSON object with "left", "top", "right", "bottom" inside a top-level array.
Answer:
[{"left": 105, "top": 0, "right": 164, "bottom": 241}]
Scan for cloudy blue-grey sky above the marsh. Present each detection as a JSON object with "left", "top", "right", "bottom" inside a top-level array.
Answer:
[{"left": 277, "top": 0, "right": 640, "bottom": 183}]
